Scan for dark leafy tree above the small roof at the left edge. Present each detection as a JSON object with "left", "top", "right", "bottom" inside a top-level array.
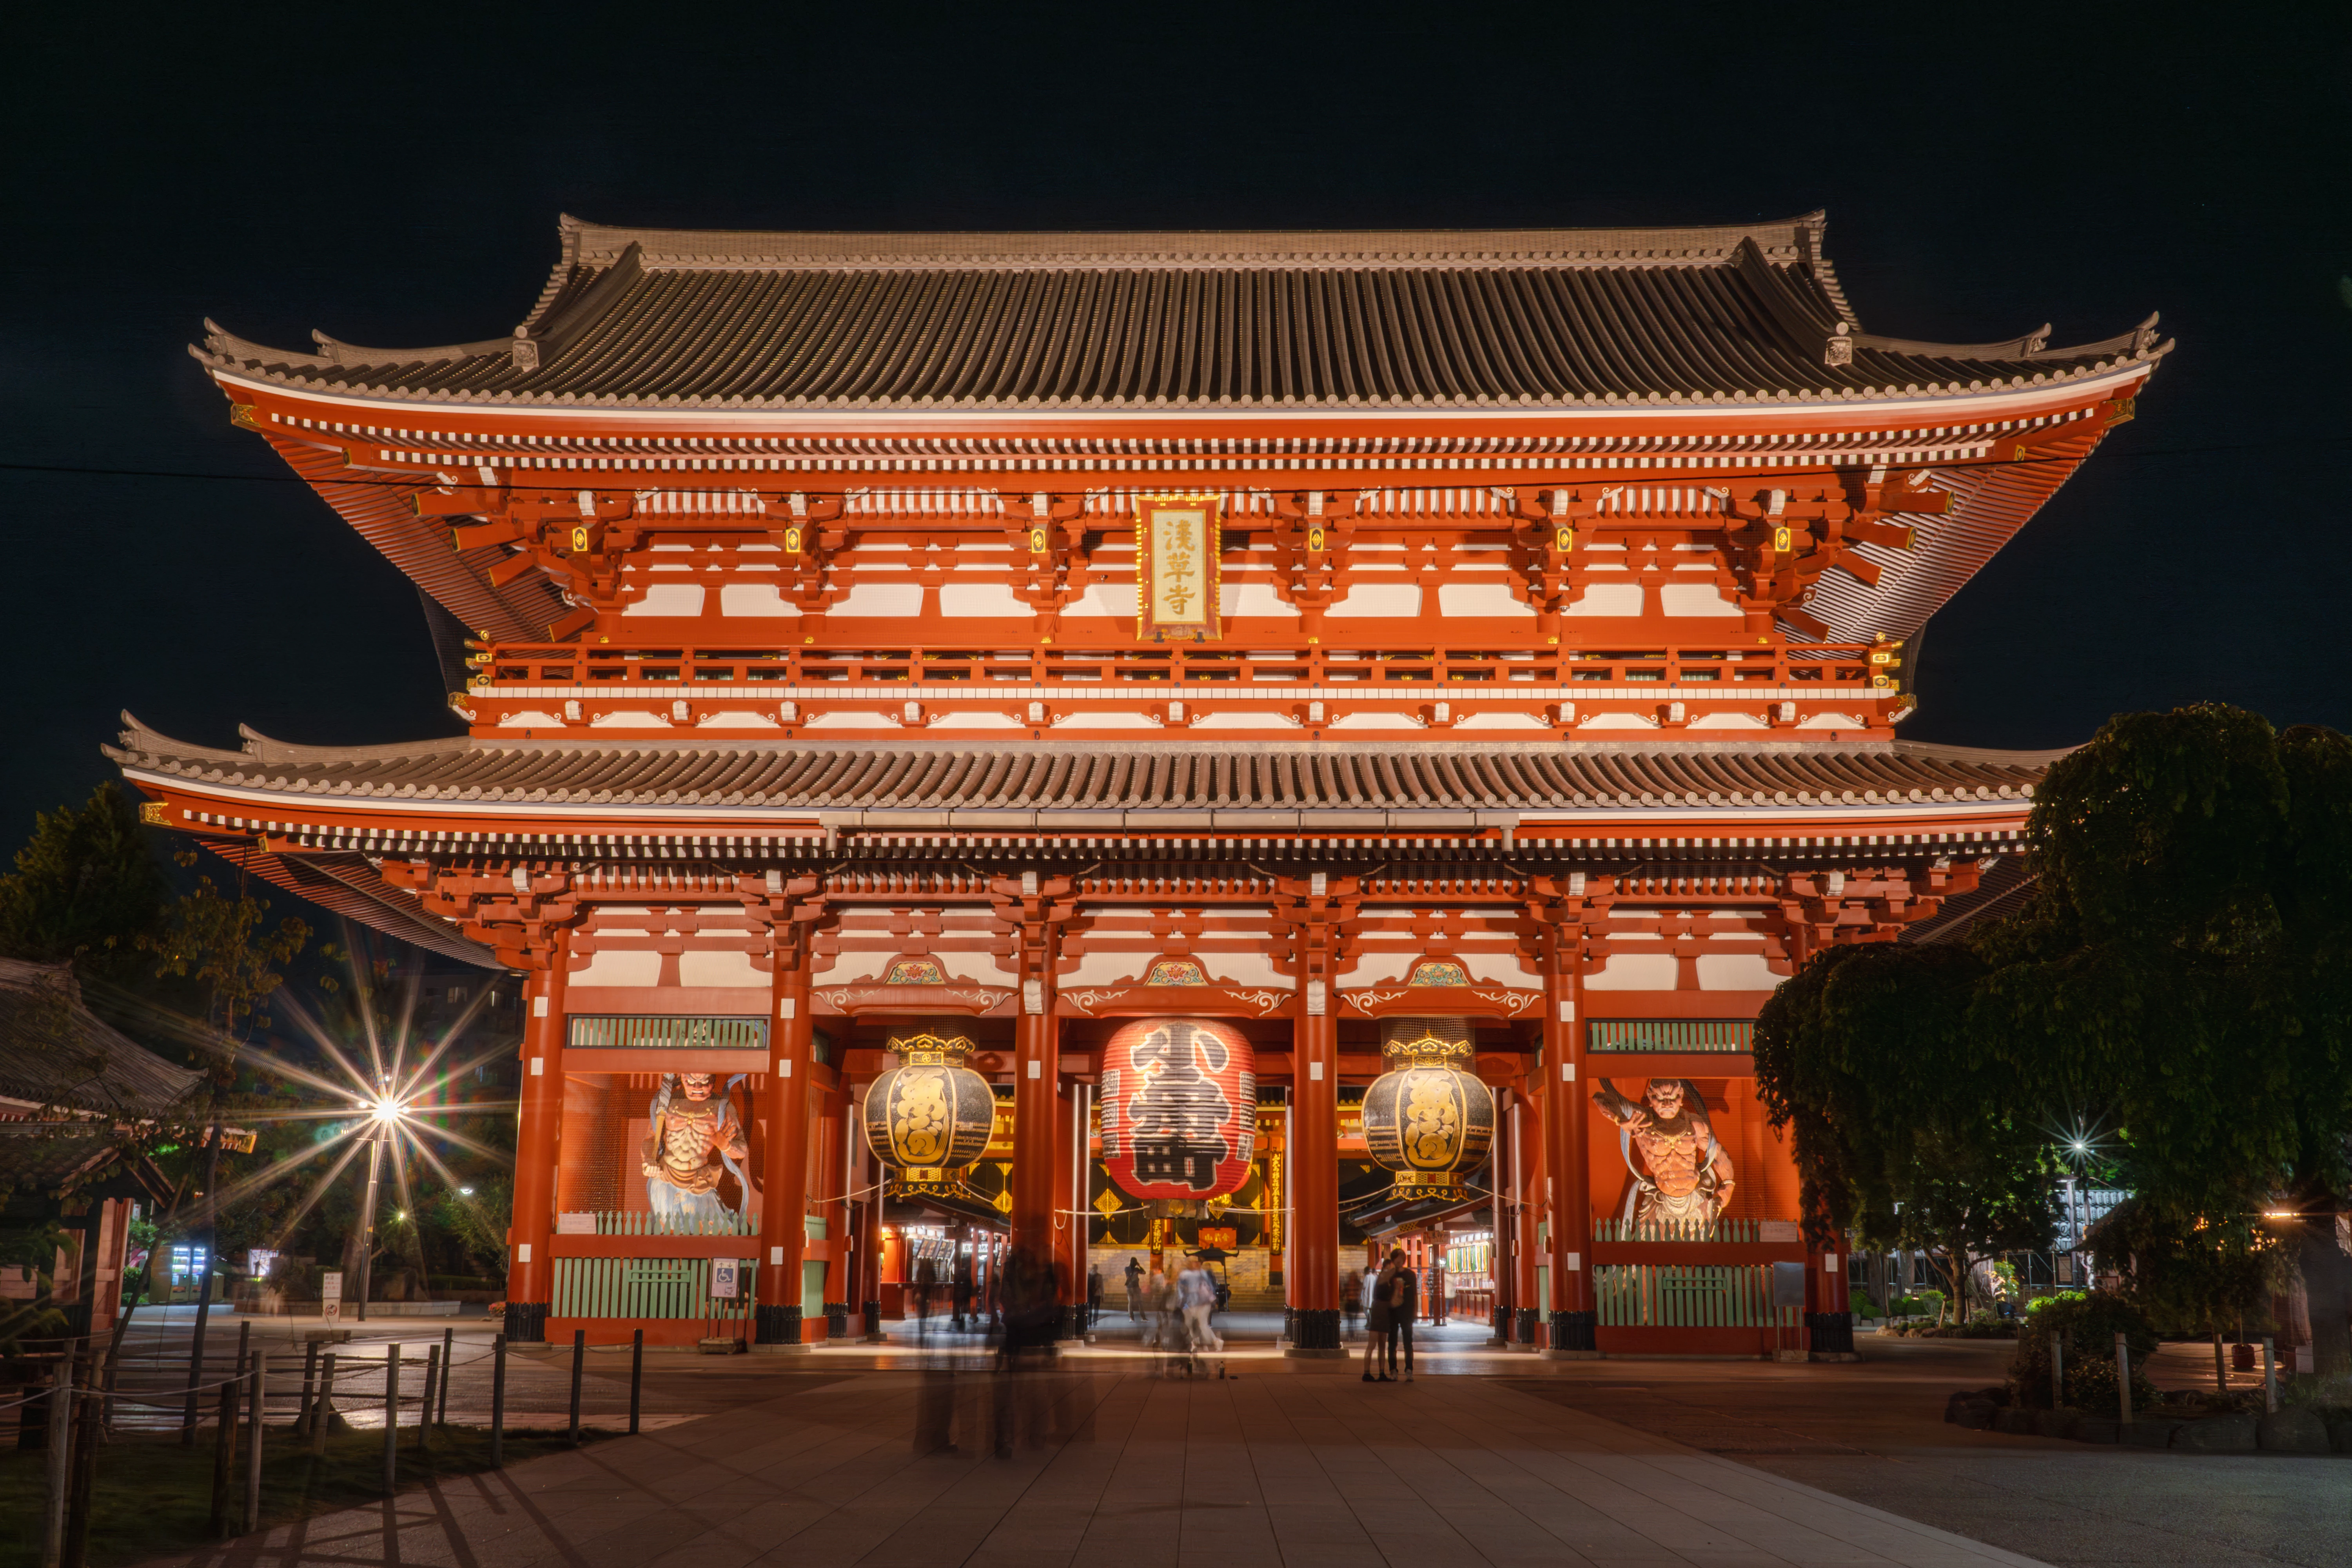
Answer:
[{"left": 0, "top": 783, "right": 172, "bottom": 980}]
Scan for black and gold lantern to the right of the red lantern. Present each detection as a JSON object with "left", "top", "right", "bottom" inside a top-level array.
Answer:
[{"left": 1364, "top": 1018, "right": 1494, "bottom": 1199}]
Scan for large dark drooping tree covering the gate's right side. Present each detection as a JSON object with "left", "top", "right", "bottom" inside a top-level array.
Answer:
[{"left": 1757, "top": 705, "right": 2352, "bottom": 1375}]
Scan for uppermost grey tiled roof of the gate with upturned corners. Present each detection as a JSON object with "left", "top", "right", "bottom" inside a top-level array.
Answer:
[{"left": 193, "top": 214, "right": 2166, "bottom": 409}]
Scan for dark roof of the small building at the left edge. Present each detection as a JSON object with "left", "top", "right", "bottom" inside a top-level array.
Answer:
[{"left": 0, "top": 959, "right": 202, "bottom": 1119}]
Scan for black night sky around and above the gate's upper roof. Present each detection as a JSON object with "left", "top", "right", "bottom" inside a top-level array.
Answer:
[{"left": 0, "top": 5, "right": 2352, "bottom": 846}]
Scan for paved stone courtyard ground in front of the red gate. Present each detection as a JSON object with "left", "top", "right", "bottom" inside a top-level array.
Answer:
[{"left": 92, "top": 1312, "right": 2352, "bottom": 1568}]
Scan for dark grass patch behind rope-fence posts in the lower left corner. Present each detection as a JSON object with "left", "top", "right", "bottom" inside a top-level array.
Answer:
[{"left": 0, "top": 1425, "right": 612, "bottom": 1568}]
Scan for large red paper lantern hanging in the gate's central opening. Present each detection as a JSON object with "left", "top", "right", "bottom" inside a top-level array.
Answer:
[{"left": 1103, "top": 1018, "right": 1258, "bottom": 1199}]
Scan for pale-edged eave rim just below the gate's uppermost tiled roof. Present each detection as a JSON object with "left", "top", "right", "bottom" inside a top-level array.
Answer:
[{"left": 207, "top": 360, "right": 2159, "bottom": 439}]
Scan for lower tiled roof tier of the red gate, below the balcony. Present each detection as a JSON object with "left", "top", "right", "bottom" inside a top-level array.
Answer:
[{"left": 106, "top": 715, "right": 2063, "bottom": 825}]
